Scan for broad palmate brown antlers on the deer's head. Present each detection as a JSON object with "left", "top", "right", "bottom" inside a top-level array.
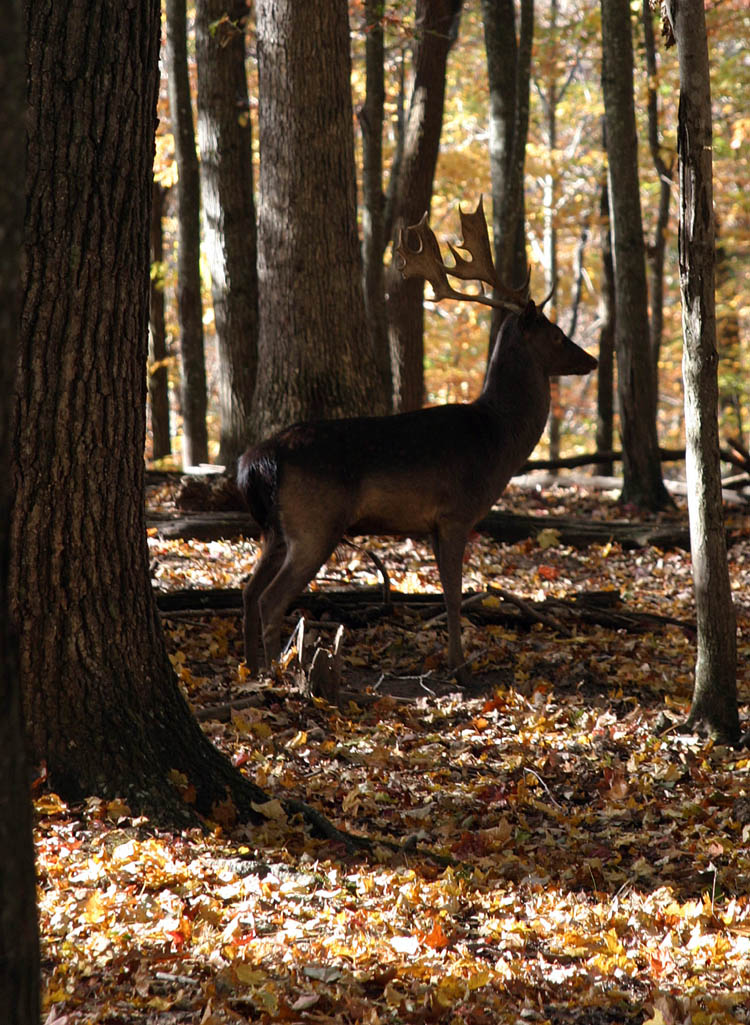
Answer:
[{"left": 395, "top": 199, "right": 531, "bottom": 313}]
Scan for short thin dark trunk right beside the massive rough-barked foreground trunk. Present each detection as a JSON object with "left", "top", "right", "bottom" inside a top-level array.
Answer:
[{"left": 149, "top": 181, "right": 172, "bottom": 459}]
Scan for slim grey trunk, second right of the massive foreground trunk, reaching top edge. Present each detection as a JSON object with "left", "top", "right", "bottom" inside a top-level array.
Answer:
[{"left": 166, "top": 0, "right": 208, "bottom": 466}]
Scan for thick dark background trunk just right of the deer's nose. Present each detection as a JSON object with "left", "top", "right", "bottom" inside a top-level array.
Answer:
[{"left": 601, "top": 0, "right": 673, "bottom": 509}]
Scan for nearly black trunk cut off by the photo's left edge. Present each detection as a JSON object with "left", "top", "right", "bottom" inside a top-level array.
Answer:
[{"left": 0, "top": 0, "right": 39, "bottom": 1025}]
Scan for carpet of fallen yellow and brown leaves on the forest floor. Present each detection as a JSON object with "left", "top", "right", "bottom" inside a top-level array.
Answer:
[{"left": 36, "top": 486, "right": 750, "bottom": 1025}]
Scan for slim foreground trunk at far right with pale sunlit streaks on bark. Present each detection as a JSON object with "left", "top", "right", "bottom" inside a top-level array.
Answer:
[{"left": 668, "top": 0, "right": 740, "bottom": 741}]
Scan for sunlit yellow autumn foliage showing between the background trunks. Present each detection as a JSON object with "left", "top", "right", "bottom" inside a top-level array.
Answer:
[{"left": 147, "top": 0, "right": 750, "bottom": 465}]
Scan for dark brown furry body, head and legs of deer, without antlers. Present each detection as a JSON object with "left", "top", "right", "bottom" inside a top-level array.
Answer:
[{"left": 238, "top": 301, "right": 596, "bottom": 683}]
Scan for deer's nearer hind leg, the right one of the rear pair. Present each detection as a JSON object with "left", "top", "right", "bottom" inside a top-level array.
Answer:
[{"left": 258, "top": 532, "right": 341, "bottom": 665}]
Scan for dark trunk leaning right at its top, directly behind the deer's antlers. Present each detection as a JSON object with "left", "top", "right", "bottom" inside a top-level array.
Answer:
[{"left": 386, "top": 0, "right": 461, "bottom": 411}]
